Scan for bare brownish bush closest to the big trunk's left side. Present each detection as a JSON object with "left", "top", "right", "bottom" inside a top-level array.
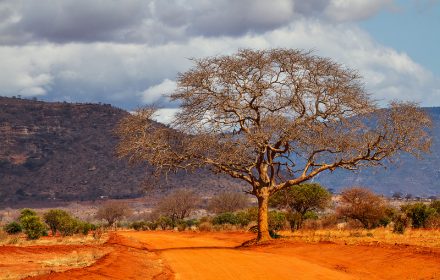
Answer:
[{"left": 208, "top": 192, "right": 249, "bottom": 214}]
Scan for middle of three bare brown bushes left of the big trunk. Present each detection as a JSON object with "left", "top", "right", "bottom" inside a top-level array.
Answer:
[{"left": 155, "top": 189, "right": 200, "bottom": 225}]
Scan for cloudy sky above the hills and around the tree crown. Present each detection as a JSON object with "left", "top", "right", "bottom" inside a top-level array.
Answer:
[{"left": 0, "top": 0, "right": 440, "bottom": 120}]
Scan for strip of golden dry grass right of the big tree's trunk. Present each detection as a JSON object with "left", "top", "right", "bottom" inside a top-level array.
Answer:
[{"left": 280, "top": 228, "right": 440, "bottom": 248}]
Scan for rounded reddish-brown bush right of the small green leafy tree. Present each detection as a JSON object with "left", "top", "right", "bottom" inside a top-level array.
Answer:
[{"left": 336, "top": 187, "right": 387, "bottom": 229}]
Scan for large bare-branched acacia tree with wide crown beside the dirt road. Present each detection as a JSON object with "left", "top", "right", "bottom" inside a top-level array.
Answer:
[{"left": 116, "top": 49, "right": 430, "bottom": 241}]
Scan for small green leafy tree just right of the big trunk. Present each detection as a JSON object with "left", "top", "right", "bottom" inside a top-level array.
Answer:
[{"left": 269, "top": 183, "right": 331, "bottom": 229}]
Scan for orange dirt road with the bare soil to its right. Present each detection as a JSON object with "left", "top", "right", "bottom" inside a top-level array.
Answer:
[{"left": 118, "top": 232, "right": 440, "bottom": 280}]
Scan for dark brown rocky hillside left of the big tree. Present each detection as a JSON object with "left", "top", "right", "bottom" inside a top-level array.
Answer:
[{"left": 0, "top": 97, "right": 244, "bottom": 204}]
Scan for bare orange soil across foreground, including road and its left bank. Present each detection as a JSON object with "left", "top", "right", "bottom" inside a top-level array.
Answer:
[{"left": 0, "top": 231, "right": 440, "bottom": 280}]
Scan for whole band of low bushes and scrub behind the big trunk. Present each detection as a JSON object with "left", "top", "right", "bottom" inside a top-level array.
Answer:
[{"left": 2, "top": 184, "right": 440, "bottom": 242}]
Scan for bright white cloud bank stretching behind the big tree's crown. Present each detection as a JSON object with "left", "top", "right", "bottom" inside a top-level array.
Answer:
[{"left": 0, "top": 19, "right": 440, "bottom": 108}]
